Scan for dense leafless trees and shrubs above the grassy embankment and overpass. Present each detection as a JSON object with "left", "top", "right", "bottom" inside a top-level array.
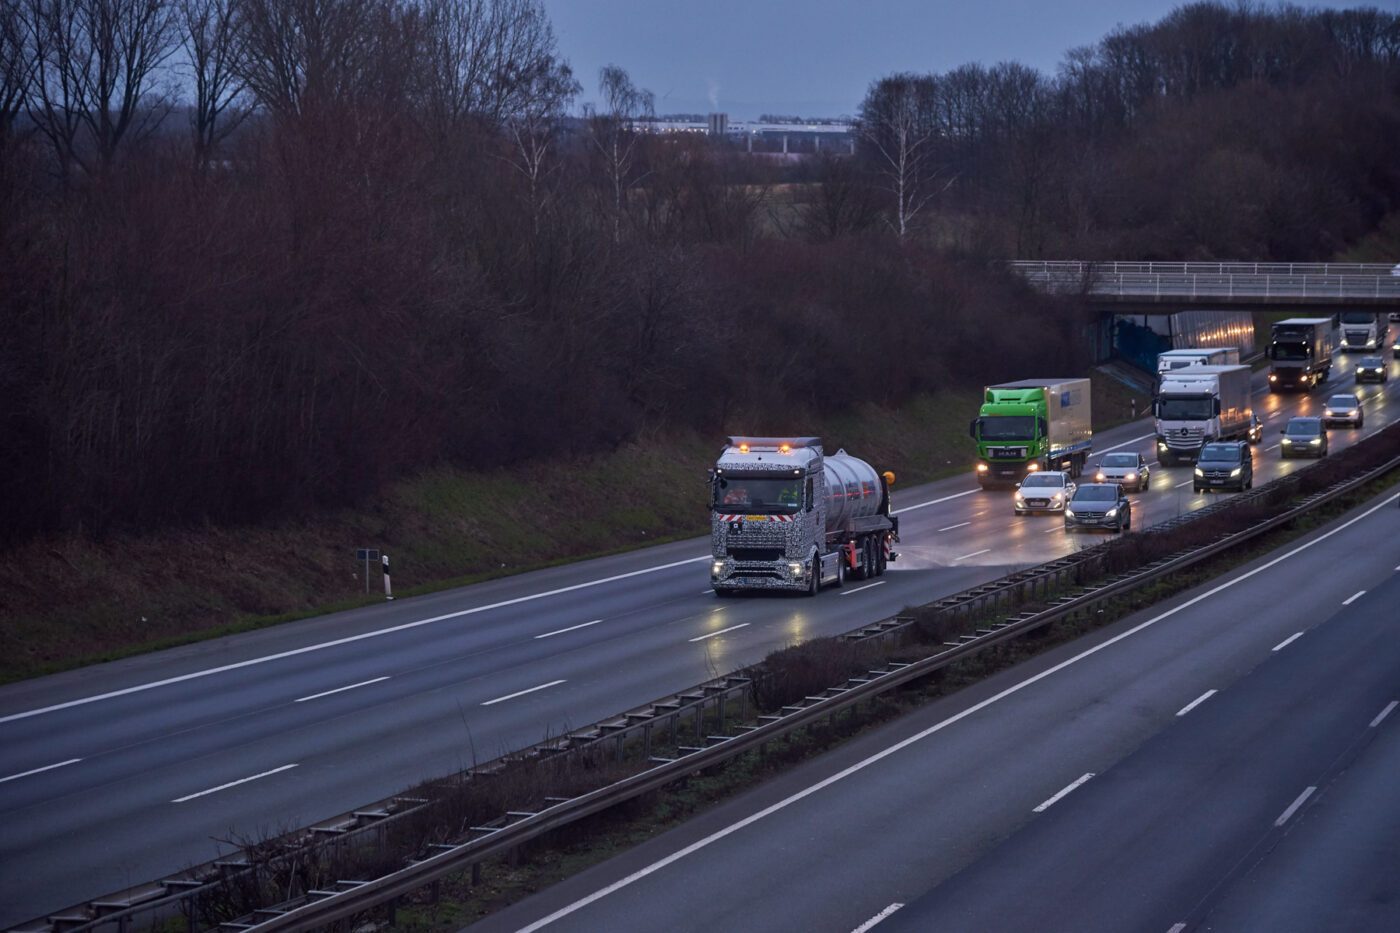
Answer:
[{"left": 0, "top": 0, "right": 1400, "bottom": 539}]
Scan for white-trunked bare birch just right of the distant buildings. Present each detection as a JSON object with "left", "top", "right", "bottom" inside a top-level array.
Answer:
[{"left": 857, "top": 74, "right": 946, "bottom": 240}]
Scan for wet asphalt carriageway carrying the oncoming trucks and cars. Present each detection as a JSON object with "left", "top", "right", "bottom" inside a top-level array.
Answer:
[{"left": 0, "top": 357, "right": 1400, "bottom": 926}]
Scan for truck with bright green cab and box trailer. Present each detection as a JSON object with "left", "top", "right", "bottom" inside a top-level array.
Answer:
[{"left": 967, "top": 380, "right": 1093, "bottom": 489}]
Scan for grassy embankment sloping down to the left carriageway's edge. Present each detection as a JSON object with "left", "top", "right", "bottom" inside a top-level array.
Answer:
[{"left": 0, "top": 378, "right": 1144, "bottom": 682}]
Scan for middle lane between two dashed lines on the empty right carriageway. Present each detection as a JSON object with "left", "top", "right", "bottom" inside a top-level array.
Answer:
[{"left": 888, "top": 565, "right": 1400, "bottom": 933}]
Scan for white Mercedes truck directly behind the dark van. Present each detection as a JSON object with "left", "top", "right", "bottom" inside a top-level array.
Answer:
[{"left": 1152, "top": 366, "right": 1254, "bottom": 467}]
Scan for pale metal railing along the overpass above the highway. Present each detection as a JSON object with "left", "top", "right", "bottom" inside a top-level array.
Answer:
[{"left": 1011, "top": 262, "right": 1400, "bottom": 304}]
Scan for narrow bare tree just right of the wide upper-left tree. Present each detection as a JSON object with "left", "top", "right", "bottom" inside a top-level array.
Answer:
[{"left": 178, "top": 0, "right": 251, "bottom": 168}]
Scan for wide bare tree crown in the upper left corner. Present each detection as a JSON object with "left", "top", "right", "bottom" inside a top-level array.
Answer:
[{"left": 20, "top": 0, "right": 174, "bottom": 172}]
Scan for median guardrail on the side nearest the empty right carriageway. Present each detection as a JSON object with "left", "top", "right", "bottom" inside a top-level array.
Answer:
[{"left": 229, "top": 437, "right": 1400, "bottom": 933}]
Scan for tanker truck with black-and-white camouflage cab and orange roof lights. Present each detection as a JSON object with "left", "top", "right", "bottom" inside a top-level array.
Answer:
[{"left": 710, "top": 436, "right": 899, "bottom": 595}]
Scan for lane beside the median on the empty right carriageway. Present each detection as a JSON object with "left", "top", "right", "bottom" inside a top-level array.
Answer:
[{"left": 467, "top": 496, "right": 1400, "bottom": 932}]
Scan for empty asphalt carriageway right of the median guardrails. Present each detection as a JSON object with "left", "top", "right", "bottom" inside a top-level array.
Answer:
[{"left": 472, "top": 481, "right": 1400, "bottom": 933}]
